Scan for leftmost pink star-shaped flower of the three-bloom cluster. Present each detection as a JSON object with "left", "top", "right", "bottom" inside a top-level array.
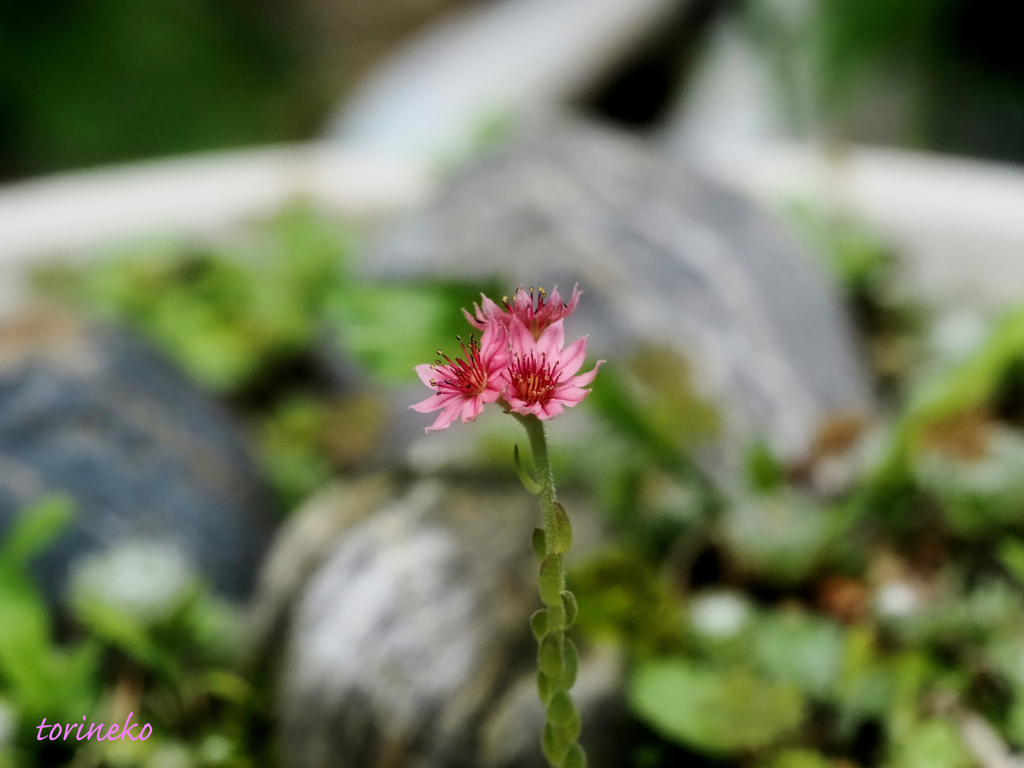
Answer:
[{"left": 410, "top": 323, "right": 509, "bottom": 432}]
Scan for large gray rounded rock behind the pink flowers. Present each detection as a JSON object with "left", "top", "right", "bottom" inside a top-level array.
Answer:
[{"left": 367, "top": 124, "right": 872, "bottom": 477}]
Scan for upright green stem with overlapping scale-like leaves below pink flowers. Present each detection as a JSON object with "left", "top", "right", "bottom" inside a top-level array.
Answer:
[{"left": 513, "top": 414, "right": 587, "bottom": 768}]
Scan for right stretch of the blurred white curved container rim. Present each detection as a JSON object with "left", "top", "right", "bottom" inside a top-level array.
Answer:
[{"left": 699, "top": 143, "right": 1024, "bottom": 309}]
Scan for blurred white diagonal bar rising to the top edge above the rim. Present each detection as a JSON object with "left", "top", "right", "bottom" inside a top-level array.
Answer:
[{"left": 329, "top": 0, "right": 686, "bottom": 161}]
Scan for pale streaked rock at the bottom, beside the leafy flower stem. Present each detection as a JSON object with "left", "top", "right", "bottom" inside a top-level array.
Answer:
[{"left": 254, "top": 477, "right": 624, "bottom": 768}]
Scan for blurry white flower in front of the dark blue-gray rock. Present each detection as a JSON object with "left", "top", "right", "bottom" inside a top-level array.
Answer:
[{"left": 72, "top": 541, "right": 195, "bottom": 621}]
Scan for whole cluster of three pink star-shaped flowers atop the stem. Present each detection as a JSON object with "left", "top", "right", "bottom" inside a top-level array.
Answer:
[{"left": 412, "top": 288, "right": 604, "bottom": 432}]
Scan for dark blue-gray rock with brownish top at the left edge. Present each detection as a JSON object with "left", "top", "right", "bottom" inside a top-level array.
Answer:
[{"left": 0, "top": 311, "right": 273, "bottom": 602}]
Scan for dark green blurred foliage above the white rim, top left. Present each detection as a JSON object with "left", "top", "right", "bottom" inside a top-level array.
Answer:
[{"left": 0, "top": 0, "right": 315, "bottom": 176}]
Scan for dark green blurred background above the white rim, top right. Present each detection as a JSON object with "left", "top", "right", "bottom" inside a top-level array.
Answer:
[{"left": 745, "top": 0, "right": 1024, "bottom": 163}]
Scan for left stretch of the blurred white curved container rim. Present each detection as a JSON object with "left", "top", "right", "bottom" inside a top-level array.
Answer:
[{"left": 0, "top": 143, "right": 428, "bottom": 310}]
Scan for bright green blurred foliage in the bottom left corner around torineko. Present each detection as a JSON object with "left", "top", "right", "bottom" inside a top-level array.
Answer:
[{"left": 0, "top": 496, "right": 266, "bottom": 768}]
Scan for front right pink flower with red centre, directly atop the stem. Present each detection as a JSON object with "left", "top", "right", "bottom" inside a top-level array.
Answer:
[{"left": 505, "top": 317, "right": 604, "bottom": 419}]
